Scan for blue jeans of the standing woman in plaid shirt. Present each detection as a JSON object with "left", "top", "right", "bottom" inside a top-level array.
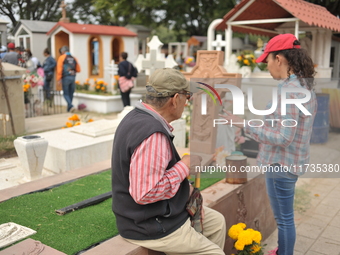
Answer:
[{"left": 266, "top": 164, "right": 298, "bottom": 255}]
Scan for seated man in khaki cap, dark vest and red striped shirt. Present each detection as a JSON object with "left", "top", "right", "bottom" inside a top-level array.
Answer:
[{"left": 111, "top": 68, "right": 226, "bottom": 255}]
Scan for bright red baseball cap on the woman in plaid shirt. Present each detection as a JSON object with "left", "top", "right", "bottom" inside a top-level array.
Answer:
[{"left": 256, "top": 34, "right": 301, "bottom": 63}]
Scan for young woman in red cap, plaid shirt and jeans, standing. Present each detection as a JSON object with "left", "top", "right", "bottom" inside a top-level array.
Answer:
[{"left": 223, "top": 34, "right": 317, "bottom": 255}]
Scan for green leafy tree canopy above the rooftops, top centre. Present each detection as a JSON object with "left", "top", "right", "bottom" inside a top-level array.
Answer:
[{"left": 95, "top": 0, "right": 235, "bottom": 41}]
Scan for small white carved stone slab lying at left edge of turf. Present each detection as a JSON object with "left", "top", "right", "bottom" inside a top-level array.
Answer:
[{"left": 0, "top": 222, "right": 37, "bottom": 248}]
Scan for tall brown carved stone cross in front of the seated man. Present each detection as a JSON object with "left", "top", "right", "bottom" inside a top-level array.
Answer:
[{"left": 184, "top": 51, "right": 241, "bottom": 165}]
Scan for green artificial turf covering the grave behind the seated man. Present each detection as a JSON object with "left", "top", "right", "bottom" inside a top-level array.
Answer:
[{"left": 0, "top": 170, "right": 221, "bottom": 255}]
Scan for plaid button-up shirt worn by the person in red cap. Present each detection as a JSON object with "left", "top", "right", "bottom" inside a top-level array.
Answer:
[{"left": 244, "top": 75, "right": 317, "bottom": 175}]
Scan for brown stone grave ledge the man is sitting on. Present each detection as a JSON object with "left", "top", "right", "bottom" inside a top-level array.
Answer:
[{"left": 83, "top": 175, "right": 276, "bottom": 255}]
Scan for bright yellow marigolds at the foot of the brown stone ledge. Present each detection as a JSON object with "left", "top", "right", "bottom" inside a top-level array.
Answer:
[{"left": 228, "top": 223, "right": 264, "bottom": 255}]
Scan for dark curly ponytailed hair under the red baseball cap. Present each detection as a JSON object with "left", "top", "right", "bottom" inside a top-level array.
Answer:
[{"left": 271, "top": 40, "right": 316, "bottom": 90}]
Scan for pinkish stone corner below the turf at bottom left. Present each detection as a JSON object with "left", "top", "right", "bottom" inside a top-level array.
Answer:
[{"left": 0, "top": 238, "right": 66, "bottom": 255}]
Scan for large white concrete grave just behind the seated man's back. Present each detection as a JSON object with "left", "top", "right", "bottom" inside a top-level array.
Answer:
[{"left": 39, "top": 123, "right": 117, "bottom": 173}]
